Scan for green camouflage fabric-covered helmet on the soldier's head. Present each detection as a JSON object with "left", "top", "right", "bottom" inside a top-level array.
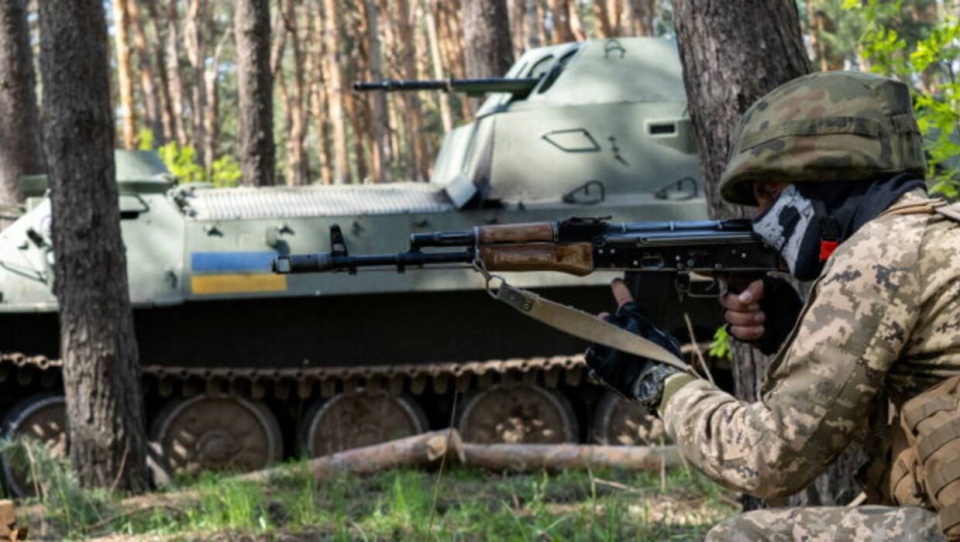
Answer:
[{"left": 720, "top": 71, "right": 926, "bottom": 205}]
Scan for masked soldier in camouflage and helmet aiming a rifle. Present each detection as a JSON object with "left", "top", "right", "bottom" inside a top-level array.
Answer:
[{"left": 587, "top": 72, "right": 960, "bottom": 541}]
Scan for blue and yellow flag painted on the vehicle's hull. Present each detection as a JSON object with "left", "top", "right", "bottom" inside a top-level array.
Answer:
[{"left": 190, "top": 251, "right": 287, "bottom": 295}]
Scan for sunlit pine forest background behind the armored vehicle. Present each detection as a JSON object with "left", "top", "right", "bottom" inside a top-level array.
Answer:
[{"left": 7, "top": 0, "right": 960, "bottom": 203}]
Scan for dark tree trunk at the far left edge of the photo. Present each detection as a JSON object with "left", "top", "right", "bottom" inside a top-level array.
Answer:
[{"left": 0, "top": 0, "right": 44, "bottom": 217}]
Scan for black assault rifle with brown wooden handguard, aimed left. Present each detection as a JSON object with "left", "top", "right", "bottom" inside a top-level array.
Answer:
[{"left": 273, "top": 217, "right": 782, "bottom": 295}]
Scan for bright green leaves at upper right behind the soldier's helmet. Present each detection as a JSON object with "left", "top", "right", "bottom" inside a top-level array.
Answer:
[{"left": 844, "top": 0, "right": 960, "bottom": 200}]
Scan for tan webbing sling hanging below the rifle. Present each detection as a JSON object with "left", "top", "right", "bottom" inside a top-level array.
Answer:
[{"left": 494, "top": 282, "right": 692, "bottom": 373}]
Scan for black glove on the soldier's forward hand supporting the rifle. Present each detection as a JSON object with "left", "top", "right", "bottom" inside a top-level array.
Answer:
[{"left": 586, "top": 302, "right": 682, "bottom": 412}]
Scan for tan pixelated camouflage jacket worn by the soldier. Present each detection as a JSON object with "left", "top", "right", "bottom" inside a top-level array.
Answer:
[{"left": 661, "top": 194, "right": 960, "bottom": 540}]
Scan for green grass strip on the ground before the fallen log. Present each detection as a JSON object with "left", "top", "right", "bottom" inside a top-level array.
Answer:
[{"left": 5, "top": 440, "right": 739, "bottom": 542}]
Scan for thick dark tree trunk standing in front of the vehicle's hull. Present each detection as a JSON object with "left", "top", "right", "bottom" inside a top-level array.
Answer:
[{"left": 40, "top": 0, "right": 146, "bottom": 498}]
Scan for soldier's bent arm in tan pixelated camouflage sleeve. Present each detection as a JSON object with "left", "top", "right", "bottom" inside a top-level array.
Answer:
[{"left": 660, "top": 221, "right": 922, "bottom": 498}]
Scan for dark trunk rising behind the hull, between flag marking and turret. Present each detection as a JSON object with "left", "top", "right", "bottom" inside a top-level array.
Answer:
[{"left": 233, "top": 0, "right": 276, "bottom": 186}]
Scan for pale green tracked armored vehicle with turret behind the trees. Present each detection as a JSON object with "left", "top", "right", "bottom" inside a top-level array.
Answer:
[{"left": 0, "top": 38, "right": 716, "bottom": 493}]
